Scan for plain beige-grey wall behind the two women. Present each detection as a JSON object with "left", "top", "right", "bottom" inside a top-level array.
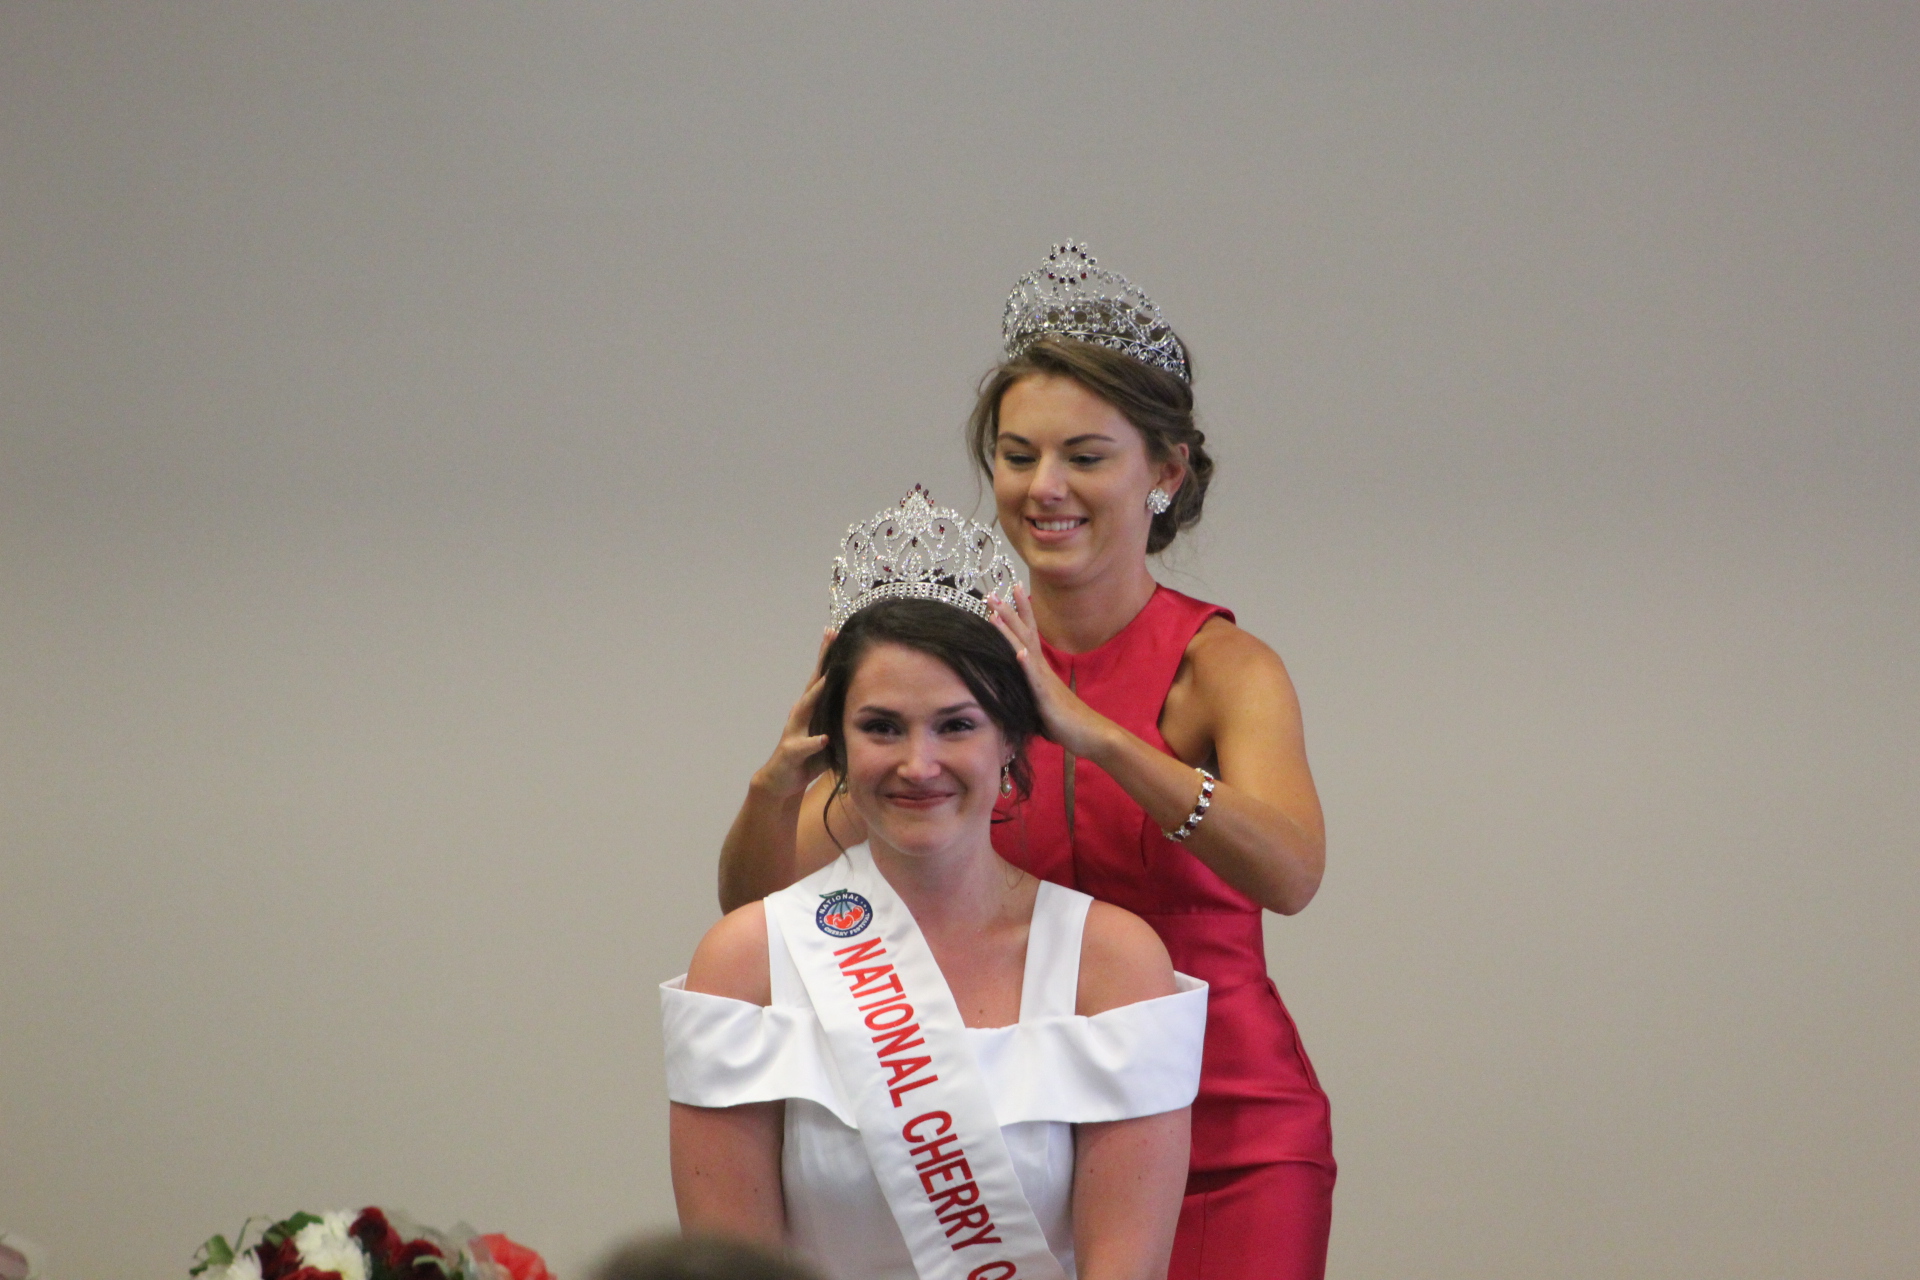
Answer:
[{"left": 0, "top": 4, "right": 1920, "bottom": 1280}]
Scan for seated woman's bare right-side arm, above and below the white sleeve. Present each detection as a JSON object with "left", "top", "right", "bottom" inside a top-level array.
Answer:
[{"left": 1073, "top": 902, "right": 1188, "bottom": 1280}]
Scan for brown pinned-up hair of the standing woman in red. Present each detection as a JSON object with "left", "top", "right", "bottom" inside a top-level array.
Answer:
[{"left": 966, "top": 334, "right": 1213, "bottom": 555}]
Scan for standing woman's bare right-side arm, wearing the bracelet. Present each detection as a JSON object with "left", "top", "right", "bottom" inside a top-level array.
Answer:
[{"left": 996, "top": 595, "right": 1327, "bottom": 915}]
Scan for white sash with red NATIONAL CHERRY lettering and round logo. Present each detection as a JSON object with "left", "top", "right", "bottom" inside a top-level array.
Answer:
[{"left": 766, "top": 844, "right": 1066, "bottom": 1280}]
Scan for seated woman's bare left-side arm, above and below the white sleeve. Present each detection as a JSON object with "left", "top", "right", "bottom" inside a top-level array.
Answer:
[{"left": 668, "top": 902, "right": 787, "bottom": 1249}]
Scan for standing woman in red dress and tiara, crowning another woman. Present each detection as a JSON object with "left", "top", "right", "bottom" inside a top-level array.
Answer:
[{"left": 720, "top": 244, "right": 1334, "bottom": 1280}]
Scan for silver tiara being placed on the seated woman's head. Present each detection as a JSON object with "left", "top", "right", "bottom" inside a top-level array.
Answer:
[{"left": 831, "top": 484, "right": 1020, "bottom": 628}]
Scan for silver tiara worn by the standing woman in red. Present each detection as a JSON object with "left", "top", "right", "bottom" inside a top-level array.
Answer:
[{"left": 1000, "top": 240, "right": 1192, "bottom": 382}]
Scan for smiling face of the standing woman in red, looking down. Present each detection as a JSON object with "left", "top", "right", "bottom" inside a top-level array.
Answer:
[{"left": 993, "top": 374, "right": 1187, "bottom": 585}]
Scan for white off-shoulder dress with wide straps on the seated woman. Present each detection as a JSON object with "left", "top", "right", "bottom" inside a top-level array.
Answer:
[{"left": 660, "top": 881, "right": 1206, "bottom": 1280}]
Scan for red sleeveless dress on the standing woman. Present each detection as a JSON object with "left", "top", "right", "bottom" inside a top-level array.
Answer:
[{"left": 993, "top": 587, "right": 1334, "bottom": 1280}]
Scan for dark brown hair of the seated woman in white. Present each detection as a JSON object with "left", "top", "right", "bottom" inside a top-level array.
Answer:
[{"left": 806, "top": 599, "right": 1041, "bottom": 809}]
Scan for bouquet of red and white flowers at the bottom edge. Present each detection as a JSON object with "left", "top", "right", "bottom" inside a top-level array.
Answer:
[{"left": 186, "top": 1209, "right": 553, "bottom": 1280}]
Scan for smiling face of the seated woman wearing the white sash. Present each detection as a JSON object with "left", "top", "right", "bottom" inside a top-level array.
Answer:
[{"left": 845, "top": 643, "right": 1010, "bottom": 854}]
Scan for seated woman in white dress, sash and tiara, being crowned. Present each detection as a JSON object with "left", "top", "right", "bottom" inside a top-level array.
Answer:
[{"left": 662, "top": 489, "right": 1206, "bottom": 1280}]
